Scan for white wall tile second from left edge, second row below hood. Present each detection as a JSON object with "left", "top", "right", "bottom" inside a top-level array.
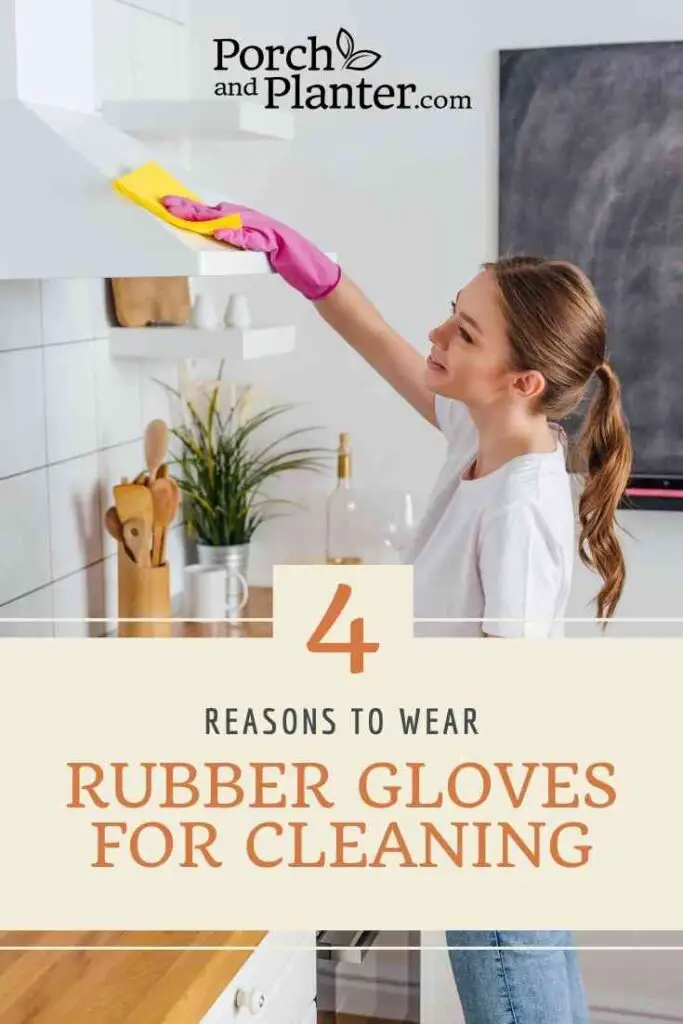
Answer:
[{"left": 44, "top": 341, "right": 97, "bottom": 463}]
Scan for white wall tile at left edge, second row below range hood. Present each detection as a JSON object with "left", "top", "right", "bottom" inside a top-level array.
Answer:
[{"left": 0, "top": 348, "right": 47, "bottom": 477}]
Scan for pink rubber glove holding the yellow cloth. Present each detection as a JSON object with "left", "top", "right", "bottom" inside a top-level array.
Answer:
[{"left": 162, "top": 196, "right": 341, "bottom": 299}]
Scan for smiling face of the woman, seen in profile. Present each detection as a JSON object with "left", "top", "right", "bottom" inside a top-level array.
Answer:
[{"left": 425, "top": 270, "right": 515, "bottom": 408}]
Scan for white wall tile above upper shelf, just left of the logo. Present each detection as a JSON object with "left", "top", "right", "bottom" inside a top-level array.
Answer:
[{"left": 132, "top": 9, "right": 189, "bottom": 99}]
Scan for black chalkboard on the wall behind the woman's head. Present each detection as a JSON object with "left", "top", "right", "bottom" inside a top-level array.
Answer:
[{"left": 499, "top": 42, "right": 683, "bottom": 507}]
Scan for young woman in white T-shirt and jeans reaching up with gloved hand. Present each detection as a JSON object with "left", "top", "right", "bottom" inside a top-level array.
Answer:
[{"left": 165, "top": 197, "right": 632, "bottom": 1024}]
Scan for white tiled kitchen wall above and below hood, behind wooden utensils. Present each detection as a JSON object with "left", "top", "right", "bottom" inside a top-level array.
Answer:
[{"left": 0, "top": 0, "right": 189, "bottom": 636}]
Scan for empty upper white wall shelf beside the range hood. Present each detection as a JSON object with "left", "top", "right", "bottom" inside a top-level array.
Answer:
[{"left": 102, "top": 99, "right": 294, "bottom": 141}]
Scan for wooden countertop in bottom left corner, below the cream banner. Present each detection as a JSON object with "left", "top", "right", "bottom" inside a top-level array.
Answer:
[{"left": 0, "top": 932, "right": 267, "bottom": 1024}]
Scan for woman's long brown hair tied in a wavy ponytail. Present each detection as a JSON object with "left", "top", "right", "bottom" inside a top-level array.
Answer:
[{"left": 482, "top": 256, "right": 633, "bottom": 618}]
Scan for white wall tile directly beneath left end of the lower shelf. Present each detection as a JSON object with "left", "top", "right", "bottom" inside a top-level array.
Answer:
[{"left": 92, "top": 338, "right": 142, "bottom": 447}]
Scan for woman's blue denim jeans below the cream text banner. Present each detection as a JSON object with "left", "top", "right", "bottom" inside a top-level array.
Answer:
[{"left": 445, "top": 932, "right": 589, "bottom": 1024}]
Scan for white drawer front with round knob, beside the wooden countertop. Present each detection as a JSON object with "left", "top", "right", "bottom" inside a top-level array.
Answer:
[{"left": 201, "top": 932, "right": 316, "bottom": 1024}]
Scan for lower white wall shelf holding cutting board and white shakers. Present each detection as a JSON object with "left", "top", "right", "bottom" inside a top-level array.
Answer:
[{"left": 110, "top": 327, "right": 296, "bottom": 360}]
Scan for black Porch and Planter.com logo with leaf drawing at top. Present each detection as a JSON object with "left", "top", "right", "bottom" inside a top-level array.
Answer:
[{"left": 214, "top": 29, "right": 472, "bottom": 111}]
